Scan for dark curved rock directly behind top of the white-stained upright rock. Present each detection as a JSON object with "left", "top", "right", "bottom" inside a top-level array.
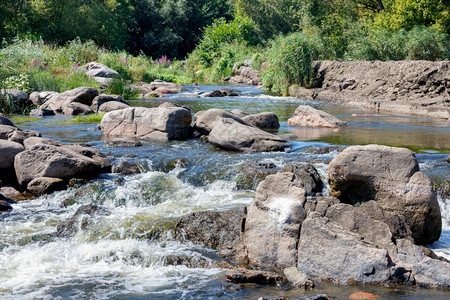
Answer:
[{"left": 281, "top": 163, "right": 324, "bottom": 195}]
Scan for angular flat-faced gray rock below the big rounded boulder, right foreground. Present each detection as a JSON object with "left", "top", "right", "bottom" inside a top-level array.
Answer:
[{"left": 298, "top": 212, "right": 389, "bottom": 284}]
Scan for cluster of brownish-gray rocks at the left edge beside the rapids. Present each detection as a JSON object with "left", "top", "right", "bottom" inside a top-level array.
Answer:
[{"left": 0, "top": 117, "right": 111, "bottom": 209}]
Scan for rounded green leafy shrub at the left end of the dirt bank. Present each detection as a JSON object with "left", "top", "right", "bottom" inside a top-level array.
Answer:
[{"left": 261, "top": 32, "right": 320, "bottom": 95}]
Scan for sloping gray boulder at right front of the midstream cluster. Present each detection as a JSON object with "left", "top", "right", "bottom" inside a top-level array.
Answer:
[{"left": 208, "top": 118, "right": 287, "bottom": 152}]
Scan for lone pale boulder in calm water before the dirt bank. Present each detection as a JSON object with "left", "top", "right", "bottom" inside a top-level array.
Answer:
[{"left": 288, "top": 105, "right": 347, "bottom": 128}]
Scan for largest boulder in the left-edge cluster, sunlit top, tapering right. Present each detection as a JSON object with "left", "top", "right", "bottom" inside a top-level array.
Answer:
[{"left": 14, "top": 145, "right": 101, "bottom": 186}]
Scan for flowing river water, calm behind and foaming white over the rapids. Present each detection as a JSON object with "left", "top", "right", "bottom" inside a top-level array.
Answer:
[{"left": 0, "top": 86, "right": 450, "bottom": 299}]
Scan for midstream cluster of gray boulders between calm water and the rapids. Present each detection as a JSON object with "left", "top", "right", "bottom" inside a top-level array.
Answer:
[{"left": 100, "top": 102, "right": 287, "bottom": 151}]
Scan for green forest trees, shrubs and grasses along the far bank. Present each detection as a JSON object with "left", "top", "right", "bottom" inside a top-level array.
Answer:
[{"left": 0, "top": 0, "right": 450, "bottom": 98}]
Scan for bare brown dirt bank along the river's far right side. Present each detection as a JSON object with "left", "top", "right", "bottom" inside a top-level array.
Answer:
[{"left": 289, "top": 61, "right": 450, "bottom": 121}]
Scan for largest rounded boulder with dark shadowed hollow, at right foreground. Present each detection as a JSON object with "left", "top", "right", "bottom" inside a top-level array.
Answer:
[{"left": 328, "top": 145, "right": 442, "bottom": 244}]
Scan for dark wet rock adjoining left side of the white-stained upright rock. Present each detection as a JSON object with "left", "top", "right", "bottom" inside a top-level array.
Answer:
[{"left": 176, "top": 209, "right": 245, "bottom": 261}]
